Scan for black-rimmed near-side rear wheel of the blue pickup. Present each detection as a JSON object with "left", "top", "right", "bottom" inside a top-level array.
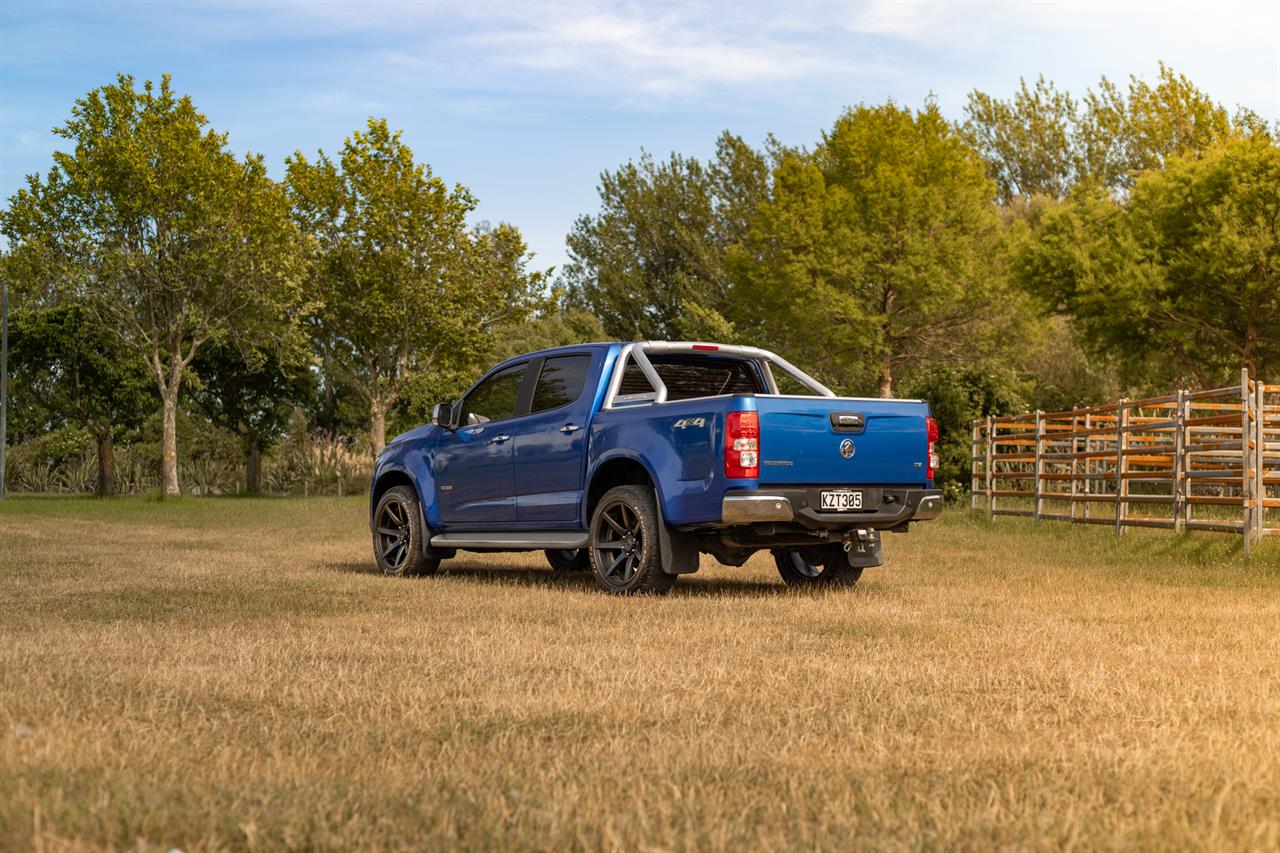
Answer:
[{"left": 588, "top": 485, "right": 676, "bottom": 596}]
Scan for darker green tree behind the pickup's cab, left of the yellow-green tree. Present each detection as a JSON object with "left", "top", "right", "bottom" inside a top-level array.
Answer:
[{"left": 563, "top": 133, "right": 768, "bottom": 339}]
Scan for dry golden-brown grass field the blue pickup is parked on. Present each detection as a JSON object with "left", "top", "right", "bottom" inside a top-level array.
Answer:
[{"left": 0, "top": 498, "right": 1280, "bottom": 850}]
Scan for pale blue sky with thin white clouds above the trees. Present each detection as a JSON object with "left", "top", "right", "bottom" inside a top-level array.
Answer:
[{"left": 0, "top": 0, "right": 1280, "bottom": 272}]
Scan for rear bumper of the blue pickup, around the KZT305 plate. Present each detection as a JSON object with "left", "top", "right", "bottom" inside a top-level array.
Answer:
[{"left": 721, "top": 485, "right": 942, "bottom": 530}]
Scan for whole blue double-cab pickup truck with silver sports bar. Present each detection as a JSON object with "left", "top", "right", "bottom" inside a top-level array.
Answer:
[{"left": 370, "top": 341, "right": 942, "bottom": 593}]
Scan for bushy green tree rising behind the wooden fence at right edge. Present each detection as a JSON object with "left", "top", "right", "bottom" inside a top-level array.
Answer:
[{"left": 1012, "top": 138, "right": 1280, "bottom": 387}]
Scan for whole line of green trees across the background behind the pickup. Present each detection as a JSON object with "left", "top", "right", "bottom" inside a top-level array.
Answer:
[{"left": 0, "top": 67, "right": 1280, "bottom": 494}]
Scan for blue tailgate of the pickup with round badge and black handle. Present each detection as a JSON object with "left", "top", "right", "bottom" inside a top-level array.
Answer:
[{"left": 755, "top": 396, "right": 929, "bottom": 487}]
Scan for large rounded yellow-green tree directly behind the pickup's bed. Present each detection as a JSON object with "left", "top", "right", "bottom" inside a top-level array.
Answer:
[{"left": 731, "top": 101, "right": 1012, "bottom": 397}]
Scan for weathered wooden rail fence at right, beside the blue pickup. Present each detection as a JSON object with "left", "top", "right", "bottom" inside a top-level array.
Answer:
[{"left": 970, "top": 370, "right": 1280, "bottom": 553}]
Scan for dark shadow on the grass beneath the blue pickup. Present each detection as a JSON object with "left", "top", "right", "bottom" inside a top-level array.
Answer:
[{"left": 321, "top": 561, "right": 834, "bottom": 598}]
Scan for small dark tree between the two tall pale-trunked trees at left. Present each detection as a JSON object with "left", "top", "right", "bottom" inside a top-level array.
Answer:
[{"left": 192, "top": 342, "right": 314, "bottom": 494}]
